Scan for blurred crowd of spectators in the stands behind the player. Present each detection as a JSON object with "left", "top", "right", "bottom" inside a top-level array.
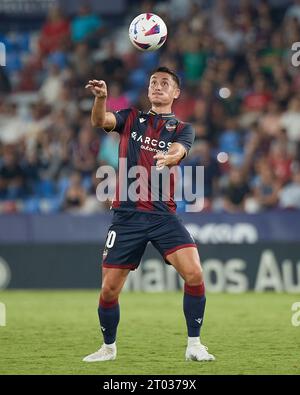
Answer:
[{"left": 0, "top": 0, "right": 300, "bottom": 213}]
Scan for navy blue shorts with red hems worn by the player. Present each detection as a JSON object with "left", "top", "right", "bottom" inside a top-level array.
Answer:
[{"left": 102, "top": 211, "right": 197, "bottom": 270}]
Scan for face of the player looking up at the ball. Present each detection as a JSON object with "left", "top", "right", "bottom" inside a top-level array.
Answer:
[{"left": 148, "top": 72, "right": 180, "bottom": 105}]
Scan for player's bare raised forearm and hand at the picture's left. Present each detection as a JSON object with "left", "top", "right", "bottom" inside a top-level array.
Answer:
[{"left": 85, "top": 80, "right": 117, "bottom": 132}]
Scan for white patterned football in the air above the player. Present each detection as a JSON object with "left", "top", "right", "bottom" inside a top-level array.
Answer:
[{"left": 129, "top": 13, "right": 168, "bottom": 51}]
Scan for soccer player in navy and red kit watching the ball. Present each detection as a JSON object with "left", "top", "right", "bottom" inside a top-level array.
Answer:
[{"left": 83, "top": 67, "right": 215, "bottom": 362}]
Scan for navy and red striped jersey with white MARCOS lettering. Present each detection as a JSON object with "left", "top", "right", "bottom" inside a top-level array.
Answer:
[{"left": 108, "top": 108, "right": 195, "bottom": 214}]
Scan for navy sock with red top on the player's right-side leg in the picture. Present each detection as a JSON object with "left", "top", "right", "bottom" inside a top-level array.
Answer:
[{"left": 183, "top": 282, "right": 206, "bottom": 337}]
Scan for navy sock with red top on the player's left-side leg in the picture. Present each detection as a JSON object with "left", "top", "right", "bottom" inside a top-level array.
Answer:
[{"left": 98, "top": 297, "right": 120, "bottom": 344}]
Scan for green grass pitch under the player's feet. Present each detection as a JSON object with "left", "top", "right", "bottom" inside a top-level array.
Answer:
[{"left": 0, "top": 291, "right": 300, "bottom": 375}]
